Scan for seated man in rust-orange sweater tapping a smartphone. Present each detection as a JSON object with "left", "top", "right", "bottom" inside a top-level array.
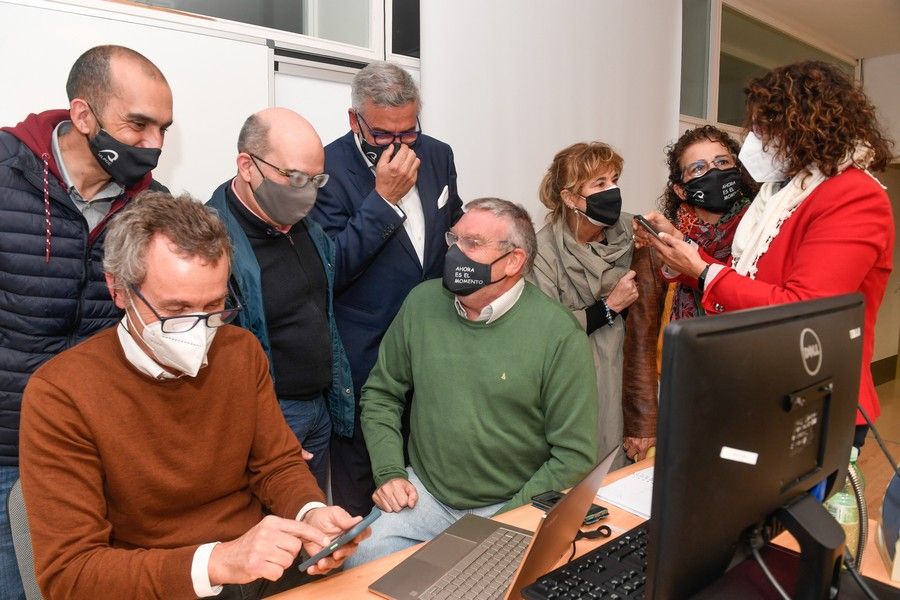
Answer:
[{"left": 21, "top": 192, "right": 365, "bottom": 599}]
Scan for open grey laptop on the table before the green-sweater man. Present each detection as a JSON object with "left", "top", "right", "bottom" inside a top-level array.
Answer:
[{"left": 369, "top": 448, "right": 618, "bottom": 600}]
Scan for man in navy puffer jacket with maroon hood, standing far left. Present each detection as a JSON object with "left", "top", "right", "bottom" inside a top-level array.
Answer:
[{"left": 0, "top": 46, "right": 172, "bottom": 599}]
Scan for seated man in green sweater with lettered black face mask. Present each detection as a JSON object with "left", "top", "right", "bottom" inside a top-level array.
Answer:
[{"left": 347, "top": 198, "right": 597, "bottom": 565}]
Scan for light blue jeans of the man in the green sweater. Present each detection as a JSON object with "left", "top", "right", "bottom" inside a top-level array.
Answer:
[{"left": 344, "top": 467, "right": 506, "bottom": 568}]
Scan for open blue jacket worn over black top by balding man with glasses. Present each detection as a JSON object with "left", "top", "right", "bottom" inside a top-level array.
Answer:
[{"left": 206, "top": 179, "right": 354, "bottom": 437}]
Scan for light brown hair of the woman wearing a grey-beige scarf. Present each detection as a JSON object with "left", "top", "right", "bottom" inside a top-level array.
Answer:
[{"left": 538, "top": 142, "right": 625, "bottom": 223}]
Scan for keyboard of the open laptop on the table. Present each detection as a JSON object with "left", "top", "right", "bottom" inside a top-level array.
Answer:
[{"left": 419, "top": 528, "right": 531, "bottom": 600}]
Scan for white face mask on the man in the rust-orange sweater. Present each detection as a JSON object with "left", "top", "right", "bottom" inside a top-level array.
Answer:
[{"left": 128, "top": 294, "right": 218, "bottom": 377}]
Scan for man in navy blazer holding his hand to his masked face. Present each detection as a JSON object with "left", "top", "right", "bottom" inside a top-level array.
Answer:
[{"left": 312, "top": 62, "right": 462, "bottom": 515}]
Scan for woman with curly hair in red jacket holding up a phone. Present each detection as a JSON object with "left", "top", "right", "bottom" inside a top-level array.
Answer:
[{"left": 640, "top": 61, "right": 894, "bottom": 446}]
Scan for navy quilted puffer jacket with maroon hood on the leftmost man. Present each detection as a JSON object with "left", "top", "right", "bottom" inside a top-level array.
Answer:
[{"left": 0, "top": 110, "right": 164, "bottom": 466}]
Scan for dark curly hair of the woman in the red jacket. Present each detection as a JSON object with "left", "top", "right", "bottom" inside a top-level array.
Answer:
[{"left": 744, "top": 61, "right": 893, "bottom": 177}]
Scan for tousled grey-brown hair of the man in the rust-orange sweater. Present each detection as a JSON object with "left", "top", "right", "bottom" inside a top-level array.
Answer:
[{"left": 103, "top": 190, "right": 231, "bottom": 289}]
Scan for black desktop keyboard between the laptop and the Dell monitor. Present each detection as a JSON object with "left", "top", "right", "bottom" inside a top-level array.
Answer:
[{"left": 522, "top": 523, "right": 647, "bottom": 600}]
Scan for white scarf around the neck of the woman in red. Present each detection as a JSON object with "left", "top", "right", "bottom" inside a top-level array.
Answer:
[{"left": 731, "top": 143, "right": 883, "bottom": 279}]
